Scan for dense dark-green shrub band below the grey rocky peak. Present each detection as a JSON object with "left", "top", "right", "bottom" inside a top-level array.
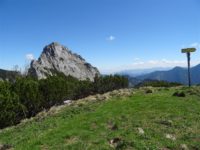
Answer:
[{"left": 0, "top": 74, "right": 128, "bottom": 128}]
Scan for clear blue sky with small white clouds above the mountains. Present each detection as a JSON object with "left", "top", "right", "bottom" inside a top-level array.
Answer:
[{"left": 0, "top": 0, "right": 200, "bottom": 73}]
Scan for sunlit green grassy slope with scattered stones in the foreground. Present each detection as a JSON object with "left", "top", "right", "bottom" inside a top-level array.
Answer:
[{"left": 0, "top": 87, "right": 200, "bottom": 150}]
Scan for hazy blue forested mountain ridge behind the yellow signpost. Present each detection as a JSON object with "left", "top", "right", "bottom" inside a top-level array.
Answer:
[{"left": 137, "top": 64, "right": 200, "bottom": 84}]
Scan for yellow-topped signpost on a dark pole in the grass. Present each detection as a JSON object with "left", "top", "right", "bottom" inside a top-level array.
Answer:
[{"left": 181, "top": 48, "right": 196, "bottom": 87}]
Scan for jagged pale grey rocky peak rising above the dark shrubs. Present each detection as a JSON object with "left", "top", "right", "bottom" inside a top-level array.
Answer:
[{"left": 28, "top": 42, "right": 100, "bottom": 81}]
